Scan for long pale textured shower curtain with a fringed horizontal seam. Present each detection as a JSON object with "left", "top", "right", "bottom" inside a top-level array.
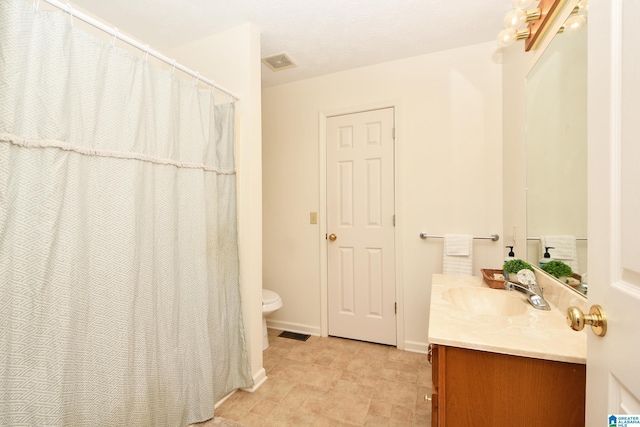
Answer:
[{"left": 0, "top": 0, "right": 252, "bottom": 426}]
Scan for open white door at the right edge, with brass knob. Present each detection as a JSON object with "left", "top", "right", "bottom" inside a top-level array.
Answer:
[{"left": 585, "top": 0, "right": 640, "bottom": 427}]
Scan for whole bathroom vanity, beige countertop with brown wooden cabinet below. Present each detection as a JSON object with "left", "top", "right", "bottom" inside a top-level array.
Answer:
[{"left": 429, "top": 274, "right": 587, "bottom": 427}]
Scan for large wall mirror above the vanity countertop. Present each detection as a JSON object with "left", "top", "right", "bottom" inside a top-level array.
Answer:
[{"left": 526, "top": 13, "right": 588, "bottom": 296}]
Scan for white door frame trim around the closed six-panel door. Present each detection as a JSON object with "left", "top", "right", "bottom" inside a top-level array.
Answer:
[{"left": 318, "top": 101, "right": 404, "bottom": 350}]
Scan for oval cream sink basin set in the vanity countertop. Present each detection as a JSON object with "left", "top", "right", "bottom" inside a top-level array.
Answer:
[{"left": 442, "top": 287, "right": 527, "bottom": 317}]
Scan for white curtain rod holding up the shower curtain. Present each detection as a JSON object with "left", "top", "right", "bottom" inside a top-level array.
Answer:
[{"left": 36, "top": 0, "right": 240, "bottom": 101}]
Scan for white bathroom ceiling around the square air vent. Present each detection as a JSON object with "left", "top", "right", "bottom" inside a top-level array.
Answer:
[{"left": 73, "top": 0, "right": 511, "bottom": 87}]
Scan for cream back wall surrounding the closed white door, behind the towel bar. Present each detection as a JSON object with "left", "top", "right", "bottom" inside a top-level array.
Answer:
[{"left": 262, "top": 43, "right": 504, "bottom": 351}]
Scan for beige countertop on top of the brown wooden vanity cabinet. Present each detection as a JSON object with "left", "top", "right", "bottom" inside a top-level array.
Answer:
[{"left": 429, "top": 274, "right": 589, "bottom": 364}]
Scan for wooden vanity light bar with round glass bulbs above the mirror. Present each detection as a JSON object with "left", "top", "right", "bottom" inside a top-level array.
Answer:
[{"left": 498, "top": 0, "right": 566, "bottom": 51}]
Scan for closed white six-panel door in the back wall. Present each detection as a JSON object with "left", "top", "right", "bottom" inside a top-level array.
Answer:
[{"left": 326, "top": 108, "right": 396, "bottom": 345}]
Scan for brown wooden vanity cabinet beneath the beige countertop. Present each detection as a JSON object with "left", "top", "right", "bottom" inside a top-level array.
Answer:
[{"left": 430, "top": 345, "right": 586, "bottom": 427}]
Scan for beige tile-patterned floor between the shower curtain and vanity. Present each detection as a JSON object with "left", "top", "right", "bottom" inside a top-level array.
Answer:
[{"left": 216, "top": 329, "right": 431, "bottom": 427}]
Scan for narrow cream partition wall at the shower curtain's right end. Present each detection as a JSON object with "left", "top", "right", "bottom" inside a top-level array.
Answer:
[{"left": 167, "top": 24, "right": 265, "bottom": 390}]
